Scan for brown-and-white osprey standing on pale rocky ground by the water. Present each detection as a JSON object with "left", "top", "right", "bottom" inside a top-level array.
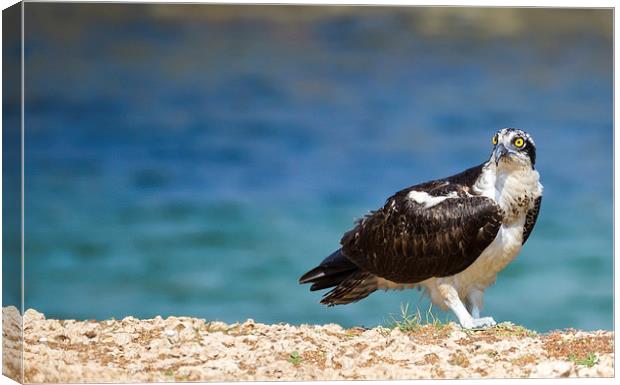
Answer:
[{"left": 299, "top": 128, "right": 543, "bottom": 328}]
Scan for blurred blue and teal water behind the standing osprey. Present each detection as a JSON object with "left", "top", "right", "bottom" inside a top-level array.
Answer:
[{"left": 19, "top": 3, "right": 613, "bottom": 331}]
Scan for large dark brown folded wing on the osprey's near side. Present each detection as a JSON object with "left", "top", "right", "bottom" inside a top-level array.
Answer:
[{"left": 340, "top": 190, "right": 502, "bottom": 283}]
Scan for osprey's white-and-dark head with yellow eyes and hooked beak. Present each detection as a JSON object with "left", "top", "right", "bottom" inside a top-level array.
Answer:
[{"left": 489, "top": 128, "right": 536, "bottom": 170}]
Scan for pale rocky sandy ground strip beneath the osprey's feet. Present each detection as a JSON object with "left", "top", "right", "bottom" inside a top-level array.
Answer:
[{"left": 2, "top": 307, "right": 614, "bottom": 383}]
